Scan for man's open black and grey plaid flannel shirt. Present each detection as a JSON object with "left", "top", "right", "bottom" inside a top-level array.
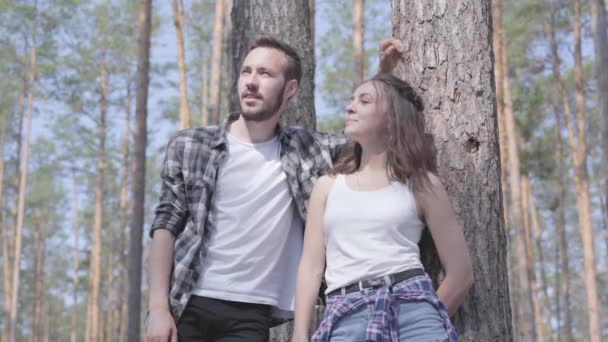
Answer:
[{"left": 150, "top": 113, "right": 345, "bottom": 324}]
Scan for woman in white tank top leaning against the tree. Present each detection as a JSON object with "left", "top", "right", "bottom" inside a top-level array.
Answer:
[{"left": 293, "top": 74, "right": 473, "bottom": 342}]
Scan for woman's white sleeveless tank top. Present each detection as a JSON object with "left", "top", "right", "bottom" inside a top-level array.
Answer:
[{"left": 324, "top": 175, "right": 424, "bottom": 293}]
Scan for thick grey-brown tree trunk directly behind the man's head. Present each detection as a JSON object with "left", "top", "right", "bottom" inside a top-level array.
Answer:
[{"left": 230, "top": 0, "right": 316, "bottom": 128}]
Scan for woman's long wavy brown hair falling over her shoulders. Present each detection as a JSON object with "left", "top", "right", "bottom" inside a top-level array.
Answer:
[{"left": 331, "top": 74, "right": 437, "bottom": 191}]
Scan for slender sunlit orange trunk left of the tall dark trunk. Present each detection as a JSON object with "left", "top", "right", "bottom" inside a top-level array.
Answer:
[{"left": 86, "top": 51, "right": 108, "bottom": 341}]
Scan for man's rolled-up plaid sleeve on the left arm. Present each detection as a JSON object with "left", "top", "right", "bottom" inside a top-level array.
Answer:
[{"left": 150, "top": 135, "right": 188, "bottom": 237}]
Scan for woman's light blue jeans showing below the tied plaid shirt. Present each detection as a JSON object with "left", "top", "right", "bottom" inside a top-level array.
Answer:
[{"left": 330, "top": 301, "right": 447, "bottom": 342}]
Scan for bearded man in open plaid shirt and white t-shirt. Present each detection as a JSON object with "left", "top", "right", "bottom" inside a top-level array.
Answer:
[{"left": 147, "top": 37, "right": 399, "bottom": 342}]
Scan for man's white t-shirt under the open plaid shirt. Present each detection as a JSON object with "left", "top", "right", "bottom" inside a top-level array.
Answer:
[{"left": 193, "top": 134, "right": 303, "bottom": 311}]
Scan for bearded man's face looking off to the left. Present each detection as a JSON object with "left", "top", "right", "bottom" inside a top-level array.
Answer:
[{"left": 237, "top": 47, "right": 287, "bottom": 121}]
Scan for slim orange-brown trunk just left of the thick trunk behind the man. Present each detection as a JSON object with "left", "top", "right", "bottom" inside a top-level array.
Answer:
[{"left": 209, "top": 0, "right": 225, "bottom": 124}]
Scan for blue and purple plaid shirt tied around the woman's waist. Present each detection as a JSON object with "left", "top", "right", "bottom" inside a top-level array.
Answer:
[{"left": 311, "top": 275, "right": 458, "bottom": 342}]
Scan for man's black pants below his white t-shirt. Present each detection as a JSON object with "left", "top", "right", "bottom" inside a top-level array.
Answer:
[{"left": 177, "top": 295, "right": 270, "bottom": 342}]
